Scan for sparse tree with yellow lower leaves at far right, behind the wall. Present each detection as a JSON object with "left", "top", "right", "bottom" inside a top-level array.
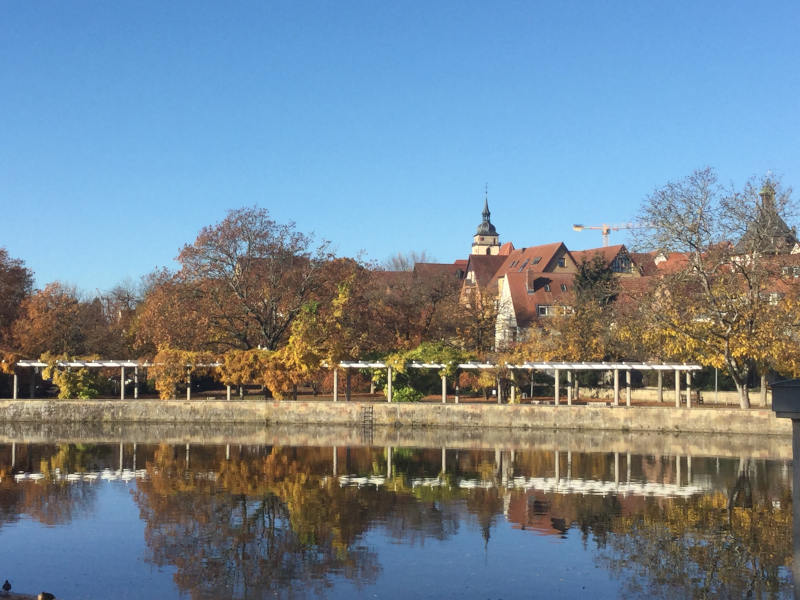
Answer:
[{"left": 640, "top": 169, "right": 796, "bottom": 408}]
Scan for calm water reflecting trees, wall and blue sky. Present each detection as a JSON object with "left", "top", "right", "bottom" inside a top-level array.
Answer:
[{"left": 0, "top": 429, "right": 794, "bottom": 600}]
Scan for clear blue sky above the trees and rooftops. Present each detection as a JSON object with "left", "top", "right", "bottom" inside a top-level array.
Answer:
[{"left": 0, "top": 0, "right": 800, "bottom": 293}]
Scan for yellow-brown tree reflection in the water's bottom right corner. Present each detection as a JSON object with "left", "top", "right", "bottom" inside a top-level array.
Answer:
[{"left": 599, "top": 469, "right": 792, "bottom": 598}]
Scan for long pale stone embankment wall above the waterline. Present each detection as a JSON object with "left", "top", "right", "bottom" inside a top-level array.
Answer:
[{"left": 0, "top": 400, "right": 791, "bottom": 436}]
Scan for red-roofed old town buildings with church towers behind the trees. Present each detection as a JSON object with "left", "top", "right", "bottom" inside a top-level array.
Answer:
[{"left": 415, "top": 185, "right": 800, "bottom": 348}]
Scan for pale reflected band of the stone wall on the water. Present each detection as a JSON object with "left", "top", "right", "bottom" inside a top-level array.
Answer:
[{"left": 0, "top": 422, "right": 792, "bottom": 460}]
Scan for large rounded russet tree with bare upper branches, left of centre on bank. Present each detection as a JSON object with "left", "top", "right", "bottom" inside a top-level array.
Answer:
[{"left": 177, "top": 207, "right": 333, "bottom": 350}]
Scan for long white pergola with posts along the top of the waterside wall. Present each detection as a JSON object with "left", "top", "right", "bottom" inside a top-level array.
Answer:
[{"left": 13, "top": 359, "right": 702, "bottom": 408}]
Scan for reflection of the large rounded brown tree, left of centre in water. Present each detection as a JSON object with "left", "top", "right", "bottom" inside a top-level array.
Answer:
[{"left": 135, "top": 446, "right": 380, "bottom": 598}]
